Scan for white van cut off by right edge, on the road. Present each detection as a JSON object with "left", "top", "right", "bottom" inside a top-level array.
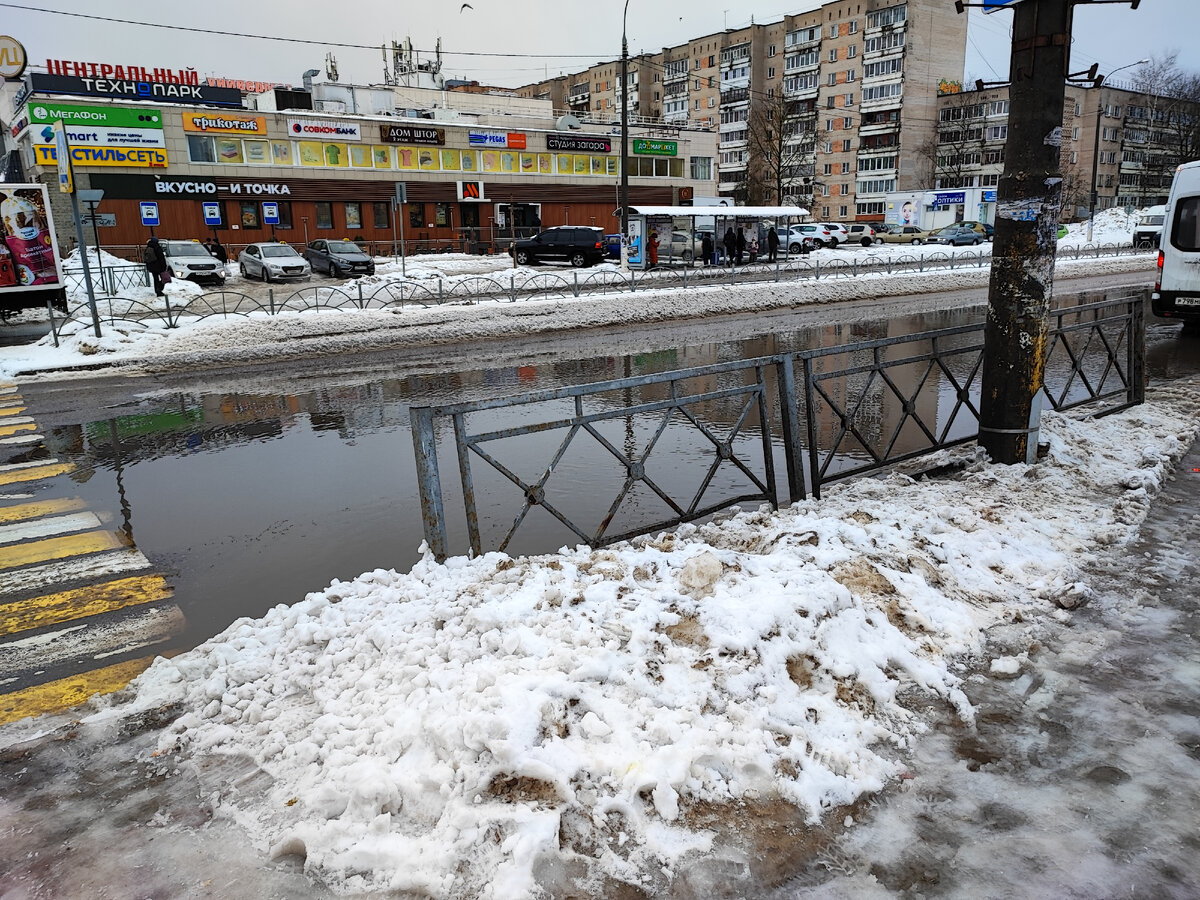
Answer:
[{"left": 1150, "top": 160, "right": 1200, "bottom": 329}]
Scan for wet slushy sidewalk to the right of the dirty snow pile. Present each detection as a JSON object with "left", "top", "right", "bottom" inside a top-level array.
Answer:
[{"left": 769, "top": 434, "right": 1200, "bottom": 900}]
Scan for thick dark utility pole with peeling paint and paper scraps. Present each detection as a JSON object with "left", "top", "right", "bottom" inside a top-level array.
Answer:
[{"left": 979, "top": 0, "right": 1072, "bottom": 463}]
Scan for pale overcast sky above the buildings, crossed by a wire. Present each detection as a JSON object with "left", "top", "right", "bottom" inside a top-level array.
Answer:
[{"left": 0, "top": 0, "right": 1200, "bottom": 86}]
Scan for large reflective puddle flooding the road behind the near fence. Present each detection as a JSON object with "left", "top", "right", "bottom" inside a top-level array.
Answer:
[{"left": 37, "top": 300, "right": 1147, "bottom": 643}]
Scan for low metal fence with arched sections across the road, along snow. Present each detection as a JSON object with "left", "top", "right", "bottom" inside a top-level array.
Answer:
[{"left": 42, "top": 245, "right": 1145, "bottom": 340}]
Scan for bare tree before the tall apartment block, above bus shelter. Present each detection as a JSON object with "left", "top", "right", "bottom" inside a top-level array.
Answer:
[{"left": 746, "top": 91, "right": 816, "bottom": 205}]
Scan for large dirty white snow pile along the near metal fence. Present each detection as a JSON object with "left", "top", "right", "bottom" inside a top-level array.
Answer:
[{"left": 96, "top": 388, "right": 1200, "bottom": 898}]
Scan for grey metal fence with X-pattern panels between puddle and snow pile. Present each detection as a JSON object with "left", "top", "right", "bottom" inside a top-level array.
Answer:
[{"left": 410, "top": 296, "right": 1145, "bottom": 559}]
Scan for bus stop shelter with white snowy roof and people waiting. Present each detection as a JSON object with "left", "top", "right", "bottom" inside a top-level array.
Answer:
[{"left": 616, "top": 205, "right": 810, "bottom": 269}]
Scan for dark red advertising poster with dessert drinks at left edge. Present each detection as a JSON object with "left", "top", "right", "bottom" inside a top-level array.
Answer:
[{"left": 0, "top": 184, "right": 64, "bottom": 294}]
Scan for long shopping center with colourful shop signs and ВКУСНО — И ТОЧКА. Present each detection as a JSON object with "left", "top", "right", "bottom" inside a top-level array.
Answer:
[{"left": 0, "top": 60, "right": 716, "bottom": 252}]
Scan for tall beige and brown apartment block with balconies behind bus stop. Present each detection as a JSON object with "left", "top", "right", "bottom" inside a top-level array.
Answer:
[{"left": 517, "top": 0, "right": 966, "bottom": 221}]
